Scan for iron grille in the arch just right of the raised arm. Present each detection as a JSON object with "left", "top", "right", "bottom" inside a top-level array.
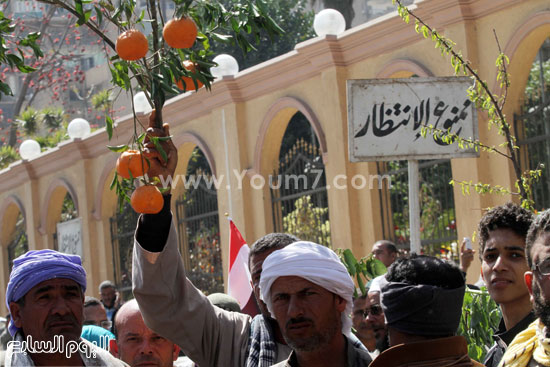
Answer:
[{"left": 176, "top": 168, "right": 223, "bottom": 294}]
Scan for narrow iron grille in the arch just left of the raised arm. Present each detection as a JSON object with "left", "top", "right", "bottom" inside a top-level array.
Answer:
[{"left": 110, "top": 202, "right": 139, "bottom": 300}]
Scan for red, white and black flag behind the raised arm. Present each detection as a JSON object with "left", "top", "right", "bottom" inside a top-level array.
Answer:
[{"left": 227, "top": 218, "right": 258, "bottom": 317}]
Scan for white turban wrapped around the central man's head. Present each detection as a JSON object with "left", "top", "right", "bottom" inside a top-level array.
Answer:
[{"left": 260, "top": 241, "right": 355, "bottom": 337}]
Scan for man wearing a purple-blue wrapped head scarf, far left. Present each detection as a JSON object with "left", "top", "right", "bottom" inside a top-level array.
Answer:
[{"left": 5, "top": 250, "right": 126, "bottom": 367}]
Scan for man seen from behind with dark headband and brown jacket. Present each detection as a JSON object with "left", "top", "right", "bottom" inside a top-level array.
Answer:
[{"left": 370, "top": 255, "right": 482, "bottom": 367}]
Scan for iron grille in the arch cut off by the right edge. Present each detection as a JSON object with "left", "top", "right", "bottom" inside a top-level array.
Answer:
[{"left": 514, "top": 38, "right": 550, "bottom": 210}]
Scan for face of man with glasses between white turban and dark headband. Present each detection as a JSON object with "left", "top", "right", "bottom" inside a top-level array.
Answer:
[{"left": 352, "top": 295, "right": 386, "bottom": 352}]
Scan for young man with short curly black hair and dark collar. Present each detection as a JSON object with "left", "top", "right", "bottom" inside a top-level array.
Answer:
[{"left": 479, "top": 203, "right": 535, "bottom": 367}]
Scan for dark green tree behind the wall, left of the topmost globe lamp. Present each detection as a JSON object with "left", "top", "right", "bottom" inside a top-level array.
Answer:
[{"left": 211, "top": 0, "right": 315, "bottom": 69}]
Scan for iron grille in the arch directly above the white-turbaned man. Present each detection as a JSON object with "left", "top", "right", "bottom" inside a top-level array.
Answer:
[{"left": 268, "top": 138, "right": 330, "bottom": 246}]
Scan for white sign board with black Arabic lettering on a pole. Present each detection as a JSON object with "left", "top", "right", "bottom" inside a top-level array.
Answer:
[{"left": 347, "top": 77, "right": 479, "bottom": 162}]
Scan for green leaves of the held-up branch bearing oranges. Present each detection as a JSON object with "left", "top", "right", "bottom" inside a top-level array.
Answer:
[{"left": 41, "top": 0, "right": 283, "bottom": 204}]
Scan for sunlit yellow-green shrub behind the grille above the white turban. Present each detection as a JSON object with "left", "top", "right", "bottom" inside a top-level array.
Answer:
[{"left": 283, "top": 195, "right": 330, "bottom": 246}]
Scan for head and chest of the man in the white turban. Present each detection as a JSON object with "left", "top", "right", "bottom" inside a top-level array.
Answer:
[{"left": 260, "top": 241, "right": 372, "bottom": 367}]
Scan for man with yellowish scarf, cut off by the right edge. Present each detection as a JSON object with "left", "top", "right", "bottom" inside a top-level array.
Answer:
[{"left": 500, "top": 210, "right": 550, "bottom": 367}]
